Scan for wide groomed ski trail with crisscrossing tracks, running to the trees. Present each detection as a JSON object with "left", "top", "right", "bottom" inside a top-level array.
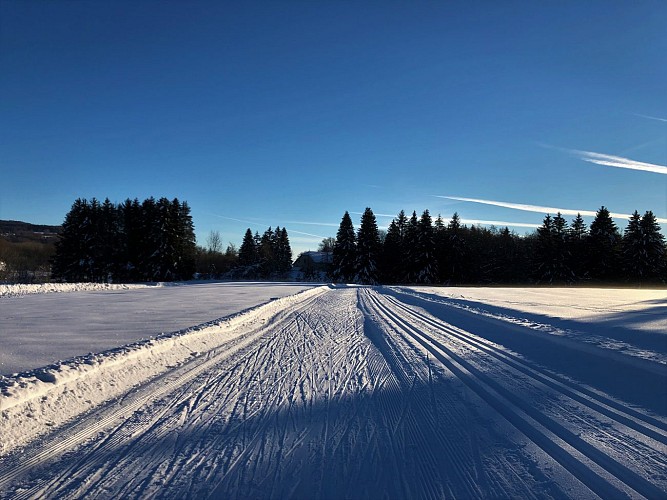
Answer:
[{"left": 0, "top": 287, "right": 667, "bottom": 498}]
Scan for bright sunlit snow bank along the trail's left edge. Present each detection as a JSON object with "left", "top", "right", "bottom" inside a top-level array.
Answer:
[{"left": 0, "top": 287, "right": 327, "bottom": 455}]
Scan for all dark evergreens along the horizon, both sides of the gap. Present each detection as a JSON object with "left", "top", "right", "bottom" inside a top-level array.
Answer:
[{"left": 34, "top": 198, "right": 667, "bottom": 285}]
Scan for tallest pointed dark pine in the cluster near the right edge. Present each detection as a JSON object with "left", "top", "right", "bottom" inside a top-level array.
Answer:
[{"left": 588, "top": 206, "right": 621, "bottom": 280}]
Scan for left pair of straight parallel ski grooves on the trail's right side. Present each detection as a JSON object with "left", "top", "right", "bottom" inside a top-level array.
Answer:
[{"left": 366, "top": 291, "right": 665, "bottom": 498}]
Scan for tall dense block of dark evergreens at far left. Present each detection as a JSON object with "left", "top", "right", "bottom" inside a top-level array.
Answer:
[{"left": 51, "top": 197, "right": 196, "bottom": 282}]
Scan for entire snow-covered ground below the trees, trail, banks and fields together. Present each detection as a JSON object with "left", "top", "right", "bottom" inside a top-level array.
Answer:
[{"left": 0, "top": 283, "right": 667, "bottom": 499}]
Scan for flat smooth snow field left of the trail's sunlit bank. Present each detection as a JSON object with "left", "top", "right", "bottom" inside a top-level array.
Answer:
[{"left": 0, "top": 281, "right": 312, "bottom": 375}]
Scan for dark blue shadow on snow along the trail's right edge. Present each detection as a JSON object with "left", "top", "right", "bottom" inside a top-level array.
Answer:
[{"left": 381, "top": 289, "right": 667, "bottom": 416}]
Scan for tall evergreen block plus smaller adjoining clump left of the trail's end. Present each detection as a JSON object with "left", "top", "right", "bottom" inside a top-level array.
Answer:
[{"left": 51, "top": 198, "right": 292, "bottom": 283}]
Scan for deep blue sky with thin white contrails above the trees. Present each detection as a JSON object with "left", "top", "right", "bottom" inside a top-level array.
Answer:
[{"left": 0, "top": 0, "right": 667, "bottom": 253}]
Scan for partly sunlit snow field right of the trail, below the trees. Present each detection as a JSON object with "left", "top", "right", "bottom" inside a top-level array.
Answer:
[{"left": 389, "top": 286, "right": 667, "bottom": 366}]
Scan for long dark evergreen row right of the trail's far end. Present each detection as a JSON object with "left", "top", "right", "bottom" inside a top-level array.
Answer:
[{"left": 330, "top": 206, "right": 667, "bottom": 284}]
